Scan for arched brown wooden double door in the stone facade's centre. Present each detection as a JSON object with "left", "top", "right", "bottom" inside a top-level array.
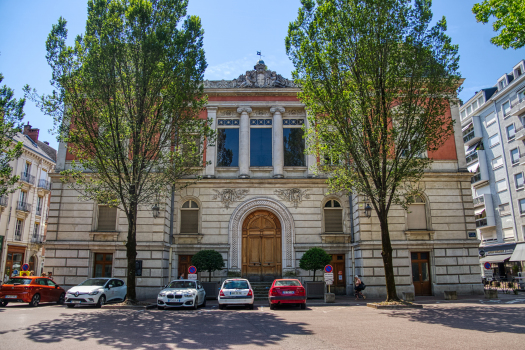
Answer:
[{"left": 242, "top": 210, "right": 282, "bottom": 282}]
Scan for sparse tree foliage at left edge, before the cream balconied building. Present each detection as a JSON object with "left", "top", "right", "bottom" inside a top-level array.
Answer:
[{"left": 0, "top": 73, "right": 26, "bottom": 196}]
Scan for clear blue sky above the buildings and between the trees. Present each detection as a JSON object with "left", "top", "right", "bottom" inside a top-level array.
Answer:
[{"left": 0, "top": 0, "right": 525, "bottom": 148}]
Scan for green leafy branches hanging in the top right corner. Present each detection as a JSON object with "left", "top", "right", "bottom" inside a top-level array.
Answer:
[{"left": 472, "top": 0, "right": 525, "bottom": 49}]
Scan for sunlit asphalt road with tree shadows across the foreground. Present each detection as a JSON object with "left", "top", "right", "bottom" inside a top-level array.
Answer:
[{"left": 0, "top": 299, "right": 525, "bottom": 350}]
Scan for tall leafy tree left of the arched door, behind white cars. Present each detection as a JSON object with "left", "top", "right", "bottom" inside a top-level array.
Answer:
[{"left": 26, "top": 0, "right": 213, "bottom": 301}]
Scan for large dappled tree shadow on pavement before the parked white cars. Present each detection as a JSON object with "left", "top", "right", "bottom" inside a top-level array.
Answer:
[{"left": 21, "top": 310, "right": 311, "bottom": 350}]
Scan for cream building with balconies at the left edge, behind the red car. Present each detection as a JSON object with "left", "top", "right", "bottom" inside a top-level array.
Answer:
[{"left": 0, "top": 124, "right": 56, "bottom": 279}]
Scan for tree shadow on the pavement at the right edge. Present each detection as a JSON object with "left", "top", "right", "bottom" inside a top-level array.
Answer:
[{"left": 388, "top": 305, "right": 525, "bottom": 334}]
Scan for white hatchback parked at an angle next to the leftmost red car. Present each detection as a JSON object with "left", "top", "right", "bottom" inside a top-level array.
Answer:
[{"left": 65, "top": 278, "right": 128, "bottom": 307}]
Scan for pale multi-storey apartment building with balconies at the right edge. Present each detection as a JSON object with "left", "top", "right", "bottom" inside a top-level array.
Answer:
[{"left": 460, "top": 60, "right": 525, "bottom": 279}]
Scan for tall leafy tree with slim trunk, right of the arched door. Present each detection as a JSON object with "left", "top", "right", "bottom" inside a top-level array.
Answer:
[{"left": 286, "top": 0, "right": 460, "bottom": 301}]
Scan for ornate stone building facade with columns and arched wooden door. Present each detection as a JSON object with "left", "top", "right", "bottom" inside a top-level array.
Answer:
[{"left": 45, "top": 61, "right": 483, "bottom": 297}]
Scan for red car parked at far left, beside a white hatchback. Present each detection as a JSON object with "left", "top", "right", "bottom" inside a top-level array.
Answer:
[{"left": 0, "top": 276, "right": 66, "bottom": 306}]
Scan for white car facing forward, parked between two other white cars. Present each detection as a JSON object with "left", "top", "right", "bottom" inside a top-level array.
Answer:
[{"left": 157, "top": 280, "right": 206, "bottom": 310}]
